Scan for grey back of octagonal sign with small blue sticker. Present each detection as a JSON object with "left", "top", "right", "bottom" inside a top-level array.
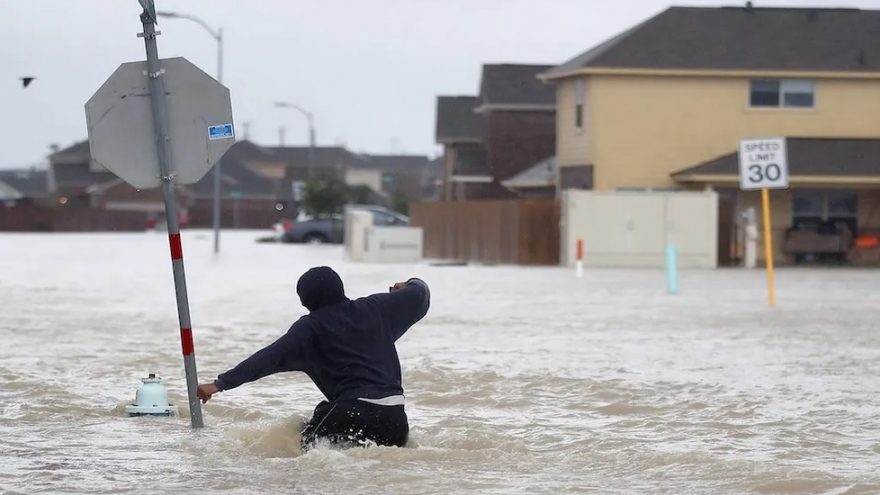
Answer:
[{"left": 85, "top": 57, "right": 235, "bottom": 189}]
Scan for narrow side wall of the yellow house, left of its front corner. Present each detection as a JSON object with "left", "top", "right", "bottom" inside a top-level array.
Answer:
[{"left": 556, "top": 77, "right": 593, "bottom": 167}]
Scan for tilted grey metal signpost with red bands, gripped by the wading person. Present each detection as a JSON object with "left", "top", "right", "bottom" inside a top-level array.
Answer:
[{"left": 141, "top": 11, "right": 204, "bottom": 429}]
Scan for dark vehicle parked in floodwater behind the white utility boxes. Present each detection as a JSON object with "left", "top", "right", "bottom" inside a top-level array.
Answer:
[{"left": 275, "top": 205, "right": 409, "bottom": 244}]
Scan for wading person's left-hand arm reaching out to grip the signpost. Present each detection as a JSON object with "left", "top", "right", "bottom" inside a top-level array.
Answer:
[{"left": 199, "top": 319, "right": 312, "bottom": 401}]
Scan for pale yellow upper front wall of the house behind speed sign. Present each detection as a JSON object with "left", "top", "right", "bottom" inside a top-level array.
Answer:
[{"left": 576, "top": 76, "right": 880, "bottom": 190}]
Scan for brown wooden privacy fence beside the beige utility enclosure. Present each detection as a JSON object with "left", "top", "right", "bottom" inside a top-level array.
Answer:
[{"left": 409, "top": 199, "right": 559, "bottom": 265}]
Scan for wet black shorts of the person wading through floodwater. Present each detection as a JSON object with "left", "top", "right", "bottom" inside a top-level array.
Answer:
[{"left": 301, "top": 400, "right": 409, "bottom": 452}]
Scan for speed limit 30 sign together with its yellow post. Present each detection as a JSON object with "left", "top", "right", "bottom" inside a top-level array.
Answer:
[{"left": 739, "top": 138, "right": 788, "bottom": 307}]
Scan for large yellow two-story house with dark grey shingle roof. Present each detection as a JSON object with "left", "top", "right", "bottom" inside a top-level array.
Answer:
[{"left": 540, "top": 2, "right": 880, "bottom": 264}]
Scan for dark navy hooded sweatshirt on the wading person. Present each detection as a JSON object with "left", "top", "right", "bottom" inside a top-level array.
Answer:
[{"left": 214, "top": 267, "right": 431, "bottom": 402}]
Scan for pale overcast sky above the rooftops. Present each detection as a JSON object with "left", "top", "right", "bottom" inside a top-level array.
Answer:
[{"left": 0, "top": 0, "right": 880, "bottom": 168}]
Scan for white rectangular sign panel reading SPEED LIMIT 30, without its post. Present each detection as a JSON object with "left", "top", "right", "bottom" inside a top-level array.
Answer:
[{"left": 739, "top": 138, "right": 788, "bottom": 191}]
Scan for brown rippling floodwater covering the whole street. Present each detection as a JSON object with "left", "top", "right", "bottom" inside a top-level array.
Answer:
[{"left": 0, "top": 231, "right": 880, "bottom": 495}]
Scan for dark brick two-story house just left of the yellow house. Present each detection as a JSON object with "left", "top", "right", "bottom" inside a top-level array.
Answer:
[{"left": 436, "top": 64, "right": 556, "bottom": 200}]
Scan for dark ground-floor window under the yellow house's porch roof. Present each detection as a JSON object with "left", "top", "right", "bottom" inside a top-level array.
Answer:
[{"left": 791, "top": 189, "right": 859, "bottom": 232}]
